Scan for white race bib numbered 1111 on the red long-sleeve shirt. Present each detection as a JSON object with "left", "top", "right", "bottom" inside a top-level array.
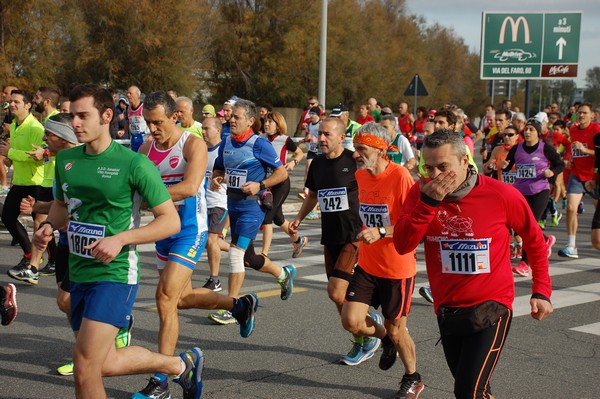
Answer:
[{"left": 440, "top": 238, "right": 490, "bottom": 274}]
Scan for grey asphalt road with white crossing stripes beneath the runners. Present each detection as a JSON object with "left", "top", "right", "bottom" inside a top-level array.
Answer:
[{"left": 0, "top": 164, "right": 600, "bottom": 399}]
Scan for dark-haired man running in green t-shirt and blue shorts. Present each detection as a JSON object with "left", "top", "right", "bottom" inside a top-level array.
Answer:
[{"left": 34, "top": 85, "right": 204, "bottom": 399}]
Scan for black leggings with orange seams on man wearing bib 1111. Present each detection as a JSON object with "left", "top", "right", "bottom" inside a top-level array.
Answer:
[{"left": 442, "top": 310, "right": 512, "bottom": 399}]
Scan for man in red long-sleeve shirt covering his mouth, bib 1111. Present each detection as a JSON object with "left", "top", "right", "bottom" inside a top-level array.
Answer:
[{"left": 394, "top": 129, "right": 553, "bottom": 398}]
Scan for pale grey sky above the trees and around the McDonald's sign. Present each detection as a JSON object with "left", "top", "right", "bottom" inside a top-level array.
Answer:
[{"left": 406, "top": 0, "right": 600, "bottom": 88}]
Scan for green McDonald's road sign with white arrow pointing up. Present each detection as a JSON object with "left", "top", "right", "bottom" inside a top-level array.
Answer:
[{"left": 481, "top": 12, "right": 581, "bottom": 79}]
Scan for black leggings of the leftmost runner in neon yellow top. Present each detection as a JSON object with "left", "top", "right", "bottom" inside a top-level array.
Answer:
[{"left": 2, "top": 186, "right": 40, "bottom": 255}]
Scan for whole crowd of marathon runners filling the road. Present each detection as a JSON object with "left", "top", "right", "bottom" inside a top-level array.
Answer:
[{"left": 0, "top": 85, "right": 600, "bottom": 399}]
